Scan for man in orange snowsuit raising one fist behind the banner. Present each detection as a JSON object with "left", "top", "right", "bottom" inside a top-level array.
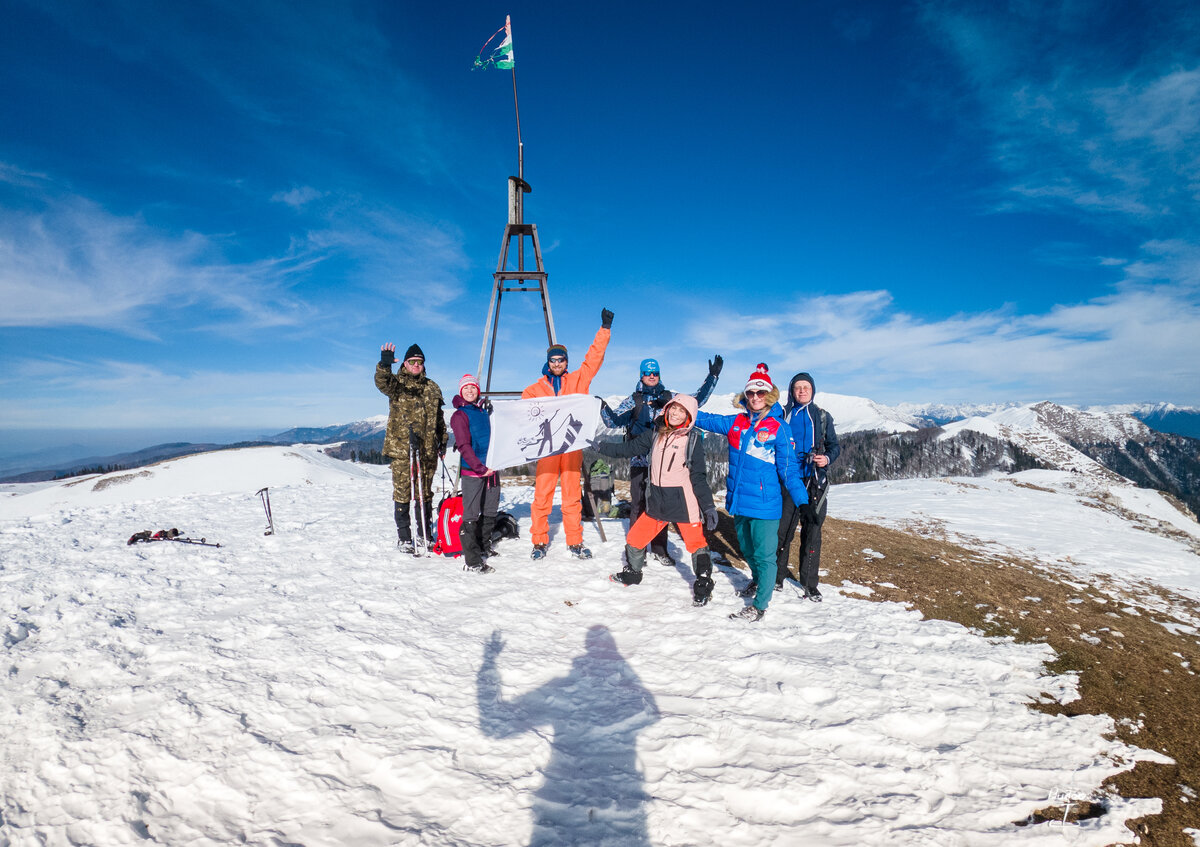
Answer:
[{"left": 521, "top": 308, "right": 612, "bottom": 559}]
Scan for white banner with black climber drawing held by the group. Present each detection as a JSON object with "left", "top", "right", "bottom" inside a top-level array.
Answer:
[{"left": 484, "top": 394, "right": 600, "bottom": 470}]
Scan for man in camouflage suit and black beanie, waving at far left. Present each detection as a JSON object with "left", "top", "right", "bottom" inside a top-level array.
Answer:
[{"left": 376, "top": 343, "right": 446, "bottom": 551}]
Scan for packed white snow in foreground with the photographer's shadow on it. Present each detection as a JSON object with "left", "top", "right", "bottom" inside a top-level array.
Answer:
[{"left": 0, "top": 447, "right": 1158, "bottom": 847}]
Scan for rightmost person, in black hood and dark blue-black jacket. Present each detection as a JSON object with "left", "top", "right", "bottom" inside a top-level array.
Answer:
[{"left": 775, "top": 372, "right": 841, "bottom": 602}]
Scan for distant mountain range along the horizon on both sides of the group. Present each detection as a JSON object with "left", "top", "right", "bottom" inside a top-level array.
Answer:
[{"left": 7, "top": 392, "right": 1200, "bottom": 512}]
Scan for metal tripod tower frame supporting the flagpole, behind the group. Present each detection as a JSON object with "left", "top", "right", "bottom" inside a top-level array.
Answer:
[{"left": 478, "top": 176, "right": 557, "bottom": 397}]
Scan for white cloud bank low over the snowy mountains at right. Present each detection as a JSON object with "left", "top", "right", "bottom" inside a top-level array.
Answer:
[{"left": 690, "top": 242, "right": 1200, "bottom": 404}]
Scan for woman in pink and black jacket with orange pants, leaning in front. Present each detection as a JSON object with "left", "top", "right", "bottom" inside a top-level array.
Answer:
[{"left": 594, "top": 395, "right": 716, "bottom": 606}]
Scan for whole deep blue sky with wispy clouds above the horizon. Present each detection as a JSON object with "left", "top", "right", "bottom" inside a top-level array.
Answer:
[{"left": 0, "top": 0, "right": 1200, "bottom": 455}]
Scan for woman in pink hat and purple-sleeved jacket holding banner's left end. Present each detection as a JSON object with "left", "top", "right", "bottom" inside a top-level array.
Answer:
[{"left": 450, "top": 373, "right": 500, "bottom": 573}]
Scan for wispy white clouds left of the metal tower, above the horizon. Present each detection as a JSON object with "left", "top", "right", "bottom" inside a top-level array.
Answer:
[{"left": 0, "top": 166, "right": 470, "bottom": 336}]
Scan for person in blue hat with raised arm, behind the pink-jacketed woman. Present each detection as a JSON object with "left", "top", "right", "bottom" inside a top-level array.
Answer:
[{"left": 600, "top": 355, "right": 721, "bottom": 567}]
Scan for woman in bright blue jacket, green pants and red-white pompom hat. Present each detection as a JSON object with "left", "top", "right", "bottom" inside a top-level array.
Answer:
[{"left": 696, "top": 362, "right": 811, "bottom": 621}]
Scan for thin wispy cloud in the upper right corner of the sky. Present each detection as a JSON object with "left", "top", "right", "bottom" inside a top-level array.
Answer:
[{"left": 924, "top": 0, "right": 1200, "bottom": 235}]
